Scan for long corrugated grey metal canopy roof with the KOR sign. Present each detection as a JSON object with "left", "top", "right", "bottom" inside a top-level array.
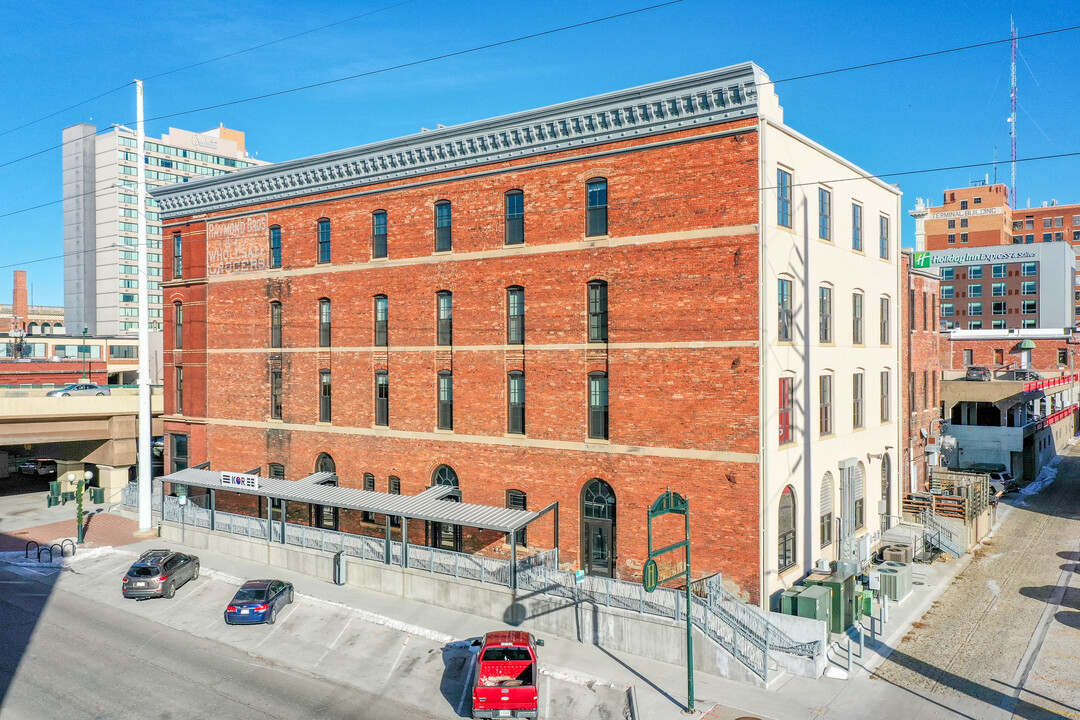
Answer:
[{"left": 154, "top": 467, "right": 548, "bottom": 533}]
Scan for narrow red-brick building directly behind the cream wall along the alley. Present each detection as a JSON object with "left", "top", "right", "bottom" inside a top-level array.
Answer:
[{"left": 901, "top": 249, "right": 950, "bottom": 492}]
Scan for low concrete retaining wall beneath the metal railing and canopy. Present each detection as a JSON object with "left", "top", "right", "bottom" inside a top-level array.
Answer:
[{"left": 161, "top": 522, "right": 825, "bottom": 687}]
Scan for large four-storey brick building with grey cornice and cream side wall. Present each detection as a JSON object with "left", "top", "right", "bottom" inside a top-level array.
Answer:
[{"left": 153, "top": 64, "right": 904, "bottom": 601}]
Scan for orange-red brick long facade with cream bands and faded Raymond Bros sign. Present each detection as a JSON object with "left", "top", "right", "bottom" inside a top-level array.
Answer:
[{"left": 164, "top": 110, "right": 759, "bottom": 593}]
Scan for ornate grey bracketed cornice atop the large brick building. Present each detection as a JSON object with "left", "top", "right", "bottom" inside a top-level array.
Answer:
[{"left": 151, "top": 63, "right": 779, "bottom": 219}]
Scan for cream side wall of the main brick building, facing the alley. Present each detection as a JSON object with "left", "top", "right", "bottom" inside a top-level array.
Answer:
[{"left": 759, "top": 118, "right": 902, "bottom": 603}]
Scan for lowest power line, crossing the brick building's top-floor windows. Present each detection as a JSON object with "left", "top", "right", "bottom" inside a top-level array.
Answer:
[{"left": 0, "top": 146, "right": 1080, "bottom": 270}]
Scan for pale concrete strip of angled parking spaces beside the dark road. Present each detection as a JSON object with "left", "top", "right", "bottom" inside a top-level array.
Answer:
[{"left": 54, "top": 548, "right": 626, "bottom": 718}]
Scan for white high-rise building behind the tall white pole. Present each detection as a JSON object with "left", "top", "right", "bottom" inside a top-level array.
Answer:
[{"left": 64, "top": 123, "right": 268, "bottom": 336}]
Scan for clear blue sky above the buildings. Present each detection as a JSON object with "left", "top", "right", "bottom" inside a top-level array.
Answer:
[{"left": 0, "top": 0, "right": 1080, "bottom": 304}]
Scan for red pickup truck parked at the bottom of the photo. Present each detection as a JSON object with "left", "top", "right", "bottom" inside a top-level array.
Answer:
[{"left": 473, "top": 630, "right": 543, "bottom": 718}]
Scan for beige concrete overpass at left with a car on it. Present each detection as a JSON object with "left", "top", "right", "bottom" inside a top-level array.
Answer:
[{"left": 0, "top": 388, "right": 162, "bottom": 501}]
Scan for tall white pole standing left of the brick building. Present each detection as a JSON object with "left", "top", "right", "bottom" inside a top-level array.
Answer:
[{"left": 135, "top": 80, "right": 152, "bottom": 530}]
